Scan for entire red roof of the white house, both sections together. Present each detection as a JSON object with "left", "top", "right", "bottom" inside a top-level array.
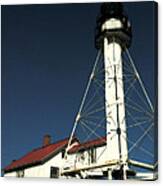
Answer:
[{"left": 4, "top": 137, "right": 106, "bottom": 172}]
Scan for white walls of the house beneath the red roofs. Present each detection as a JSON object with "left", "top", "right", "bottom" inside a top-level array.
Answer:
[{"left": 4, "top": 146, "right": 107, "bottom": 178}]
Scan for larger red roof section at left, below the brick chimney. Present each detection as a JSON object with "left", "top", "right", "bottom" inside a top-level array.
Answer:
[{"left": 4, "top": 139, "right": 68, "bottom": 171}]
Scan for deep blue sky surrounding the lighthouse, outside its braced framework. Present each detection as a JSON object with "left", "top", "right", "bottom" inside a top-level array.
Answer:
[{"left": 2, "top": 3, "right": 157, "bottom": 170}]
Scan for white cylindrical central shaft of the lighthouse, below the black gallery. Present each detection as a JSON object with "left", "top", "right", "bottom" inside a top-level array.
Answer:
[{"left": 104, "top": 29, "right": 128, "bottom": 164}]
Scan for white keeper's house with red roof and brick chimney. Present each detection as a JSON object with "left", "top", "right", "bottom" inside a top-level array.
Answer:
[{"left": 3, "top": 135, "right": 107, "bottom": 178}]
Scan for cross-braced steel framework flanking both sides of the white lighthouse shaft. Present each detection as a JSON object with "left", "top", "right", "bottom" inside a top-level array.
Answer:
[{"left": 61, "top": 49, "right": 157, "bottom": 179}]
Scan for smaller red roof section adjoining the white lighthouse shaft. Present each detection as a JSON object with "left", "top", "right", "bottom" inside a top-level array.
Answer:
[{"left": 68, "top": 137, "right": 106, "bottom": 153}]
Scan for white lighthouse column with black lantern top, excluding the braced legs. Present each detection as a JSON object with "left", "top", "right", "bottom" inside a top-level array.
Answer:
[{"left": 95, "top": 3, "right": 132, "bottom": 179}]
